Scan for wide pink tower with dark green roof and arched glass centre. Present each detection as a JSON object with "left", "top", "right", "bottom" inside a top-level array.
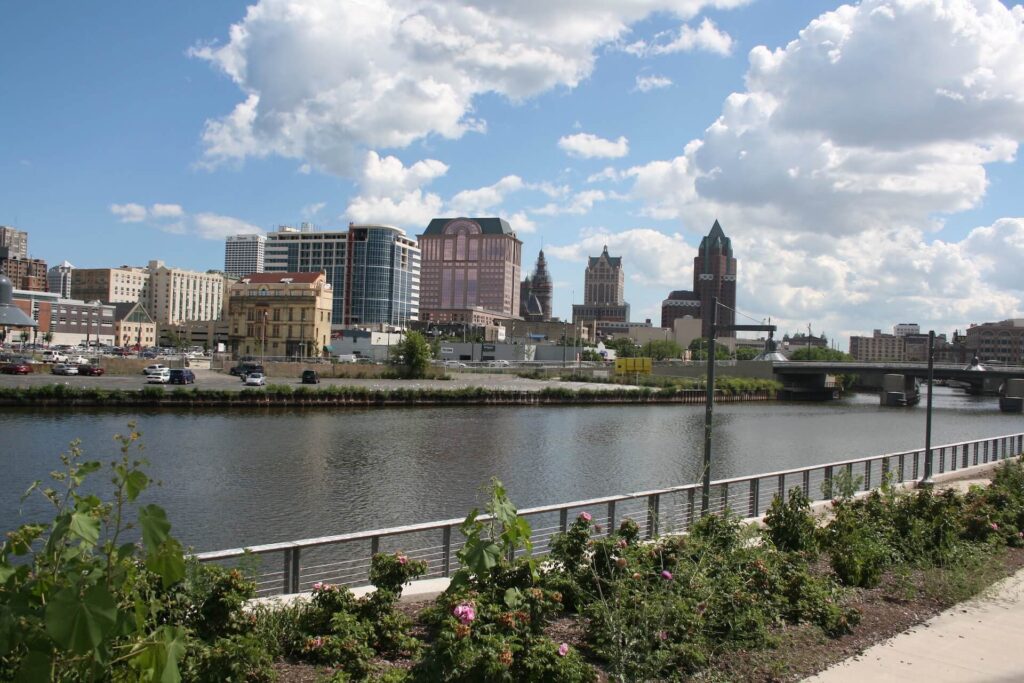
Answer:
[{"left": 420, "top": 218, "right": 522, "bottom": 326}]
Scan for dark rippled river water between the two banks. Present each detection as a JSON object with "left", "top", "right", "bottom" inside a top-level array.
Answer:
[{"left": 0, "top": 387, "right": 1024, "bottom": 551}]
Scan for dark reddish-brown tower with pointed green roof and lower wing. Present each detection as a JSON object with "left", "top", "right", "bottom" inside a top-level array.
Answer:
[{"left": 662, "top": 220, "right": 736, "bottom": 337}]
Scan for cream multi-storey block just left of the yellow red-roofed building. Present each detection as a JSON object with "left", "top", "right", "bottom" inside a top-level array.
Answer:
[{"left": 144, "top": 260, "right": 224, "bottom": 325}]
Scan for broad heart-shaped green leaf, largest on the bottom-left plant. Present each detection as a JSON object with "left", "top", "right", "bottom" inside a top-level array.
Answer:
[{"left": 45, "top": 584, "right": 118, "bottom": 654}]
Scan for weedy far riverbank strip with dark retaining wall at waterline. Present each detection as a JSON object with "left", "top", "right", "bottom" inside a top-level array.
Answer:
[{"left": 0, "top": 381, "right": 775, "bottom": 408}]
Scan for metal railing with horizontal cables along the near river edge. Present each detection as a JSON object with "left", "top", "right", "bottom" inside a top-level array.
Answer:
[{"left": 197, "top": 433, "right": 1024, "bottom": 596}]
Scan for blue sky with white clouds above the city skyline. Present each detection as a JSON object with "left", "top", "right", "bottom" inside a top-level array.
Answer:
[{"left": 0, "top": 0, "right": 1024, "bottom": 347}]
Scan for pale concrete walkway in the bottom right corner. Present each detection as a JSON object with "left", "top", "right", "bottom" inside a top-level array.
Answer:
[{"left": 806, "top": 570, "right": 1024, "bottom": 683}]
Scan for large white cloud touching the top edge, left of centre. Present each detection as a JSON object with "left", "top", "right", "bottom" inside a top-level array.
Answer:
[{"left": 190, "top": 0, "right": 750, "bottom": 176}]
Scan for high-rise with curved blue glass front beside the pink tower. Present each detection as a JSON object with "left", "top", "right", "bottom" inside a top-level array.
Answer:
[{"left": 264, "top": 223, "right": 421, "bottom": 328}]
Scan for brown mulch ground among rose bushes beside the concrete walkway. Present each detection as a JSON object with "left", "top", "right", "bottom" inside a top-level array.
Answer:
[{"left": 274, "top": 548, "right": 1024, "bottom": 683}]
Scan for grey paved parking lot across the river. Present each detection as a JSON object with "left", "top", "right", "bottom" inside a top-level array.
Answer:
[{"left": 0, "top": 369, "right": 635, "bottom": 391}]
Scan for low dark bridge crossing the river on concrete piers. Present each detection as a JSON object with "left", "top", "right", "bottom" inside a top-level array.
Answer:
[{"left": 772, "top": 361, "right": 1024, "bottom": 413}]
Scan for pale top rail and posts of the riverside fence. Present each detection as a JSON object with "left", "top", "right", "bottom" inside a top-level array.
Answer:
[{"left": 196, "top": 432, "right": 1024, "bottom": 594}]
